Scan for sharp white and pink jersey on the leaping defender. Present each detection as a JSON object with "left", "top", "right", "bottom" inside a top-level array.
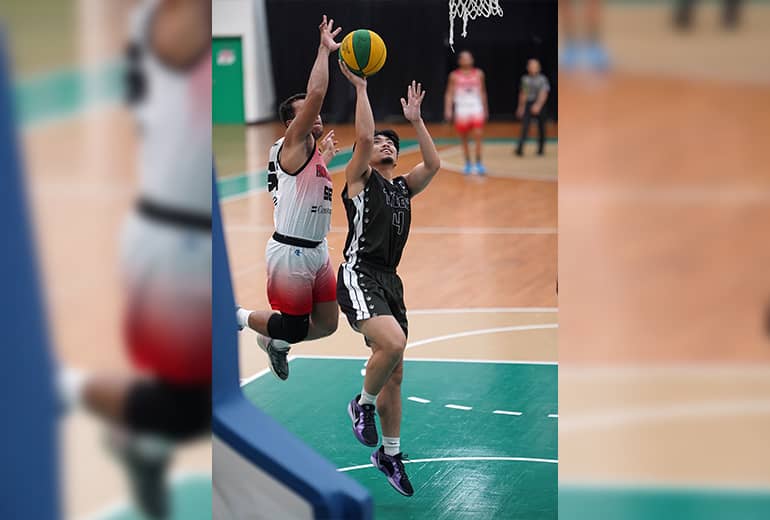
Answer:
[{"left": 267, "top": 137, "right": 332, "bottom": 242}]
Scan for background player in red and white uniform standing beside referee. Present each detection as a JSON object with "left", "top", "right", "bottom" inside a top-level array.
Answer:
[{"left": 444, "top": 51, "right": 489, "bottom": 175}]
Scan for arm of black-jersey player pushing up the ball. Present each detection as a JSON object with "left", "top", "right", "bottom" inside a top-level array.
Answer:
[{"left": 340, "top": 61, "right": 374, "bottom": 197}]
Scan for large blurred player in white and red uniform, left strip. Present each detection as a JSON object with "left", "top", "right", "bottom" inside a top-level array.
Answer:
[{"left": 60, "top": 0, "right": 212, "bottom": 518}]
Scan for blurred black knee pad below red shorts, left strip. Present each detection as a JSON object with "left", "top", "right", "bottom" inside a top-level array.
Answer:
[{"left": 124, "top": 381, "right": 211, "bottom": 441}]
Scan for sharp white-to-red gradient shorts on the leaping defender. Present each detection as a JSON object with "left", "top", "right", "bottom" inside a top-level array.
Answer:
[{"left": 265, "top": 238, "right": 337, "bottom": 316}]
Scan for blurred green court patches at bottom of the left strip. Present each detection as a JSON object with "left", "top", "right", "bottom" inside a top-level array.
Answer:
[{"left": 98, "top": 475, "right": 211, "bottom": 520}]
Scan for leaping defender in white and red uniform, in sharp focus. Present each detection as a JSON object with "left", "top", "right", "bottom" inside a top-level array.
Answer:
[{"left": 236, "top": 15, "right": 341, "bottom": 379}]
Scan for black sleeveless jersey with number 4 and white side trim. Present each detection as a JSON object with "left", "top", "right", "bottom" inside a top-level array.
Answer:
[{"left": 342, "top": 168, "right": 412, "bottom": 271}]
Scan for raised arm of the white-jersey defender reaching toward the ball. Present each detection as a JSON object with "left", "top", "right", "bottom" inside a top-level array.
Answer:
[{"left": 284, "top": 15, "right": 342, "bottom": 148}]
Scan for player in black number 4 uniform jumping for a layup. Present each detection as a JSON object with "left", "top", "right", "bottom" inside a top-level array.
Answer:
[{"left": 337, "top": 62, "right": 441, "bottom": 496}]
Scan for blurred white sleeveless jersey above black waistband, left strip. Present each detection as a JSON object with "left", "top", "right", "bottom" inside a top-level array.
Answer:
[{"left": 127, "top": 0, "right": 212, "bottom": 215}]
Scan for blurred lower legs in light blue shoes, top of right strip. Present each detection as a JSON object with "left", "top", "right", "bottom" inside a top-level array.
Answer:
[{"left": 559, "top": 0, "right": 610, "bottom": 72}]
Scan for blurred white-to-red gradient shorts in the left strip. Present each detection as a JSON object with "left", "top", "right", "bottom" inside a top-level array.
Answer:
[{"left": 122, "top": 209, "right": 211, "bottom": 384}]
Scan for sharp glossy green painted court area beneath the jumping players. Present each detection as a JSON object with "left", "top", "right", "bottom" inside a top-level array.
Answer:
[{"left": 243, "top": 358, "right": 558, "bottom": 520}]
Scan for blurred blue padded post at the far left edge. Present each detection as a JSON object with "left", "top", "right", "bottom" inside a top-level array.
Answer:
[{"left": 0, "top": 27, "right": 59, "bottom": 520}]
